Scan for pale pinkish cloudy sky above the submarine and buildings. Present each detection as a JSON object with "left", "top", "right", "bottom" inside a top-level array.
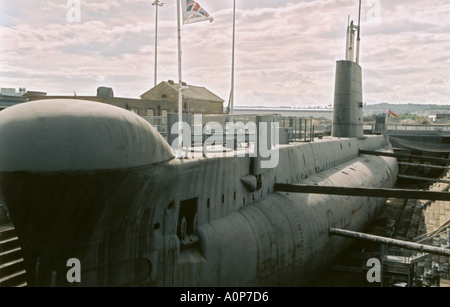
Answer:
[{"left": 0, "top": 0, "right": 450, "bottom": 107}]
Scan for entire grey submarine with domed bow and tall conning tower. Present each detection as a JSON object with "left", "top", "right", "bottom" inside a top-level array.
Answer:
[{"left": 0, "top": 3, "right": 398, "bottom": 287}]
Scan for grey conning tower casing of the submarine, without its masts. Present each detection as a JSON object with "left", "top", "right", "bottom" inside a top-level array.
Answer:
[{"left": 332, "top": 61, "right": 363, "bottom": 137}]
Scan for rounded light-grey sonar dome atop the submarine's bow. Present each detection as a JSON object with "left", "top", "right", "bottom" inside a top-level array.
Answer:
[{"left": 0, "top": 99, "right": 174, "bottom": 172}]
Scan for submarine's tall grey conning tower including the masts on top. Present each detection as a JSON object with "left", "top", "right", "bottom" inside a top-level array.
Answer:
[{"left": 332, "top": 3, "right": 364, "bottom": 138}]
